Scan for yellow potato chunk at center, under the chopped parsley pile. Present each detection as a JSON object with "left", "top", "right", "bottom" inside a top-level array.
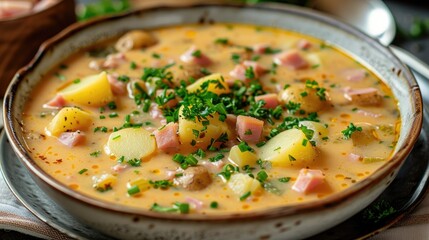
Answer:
[{"left": 179, "top": 106, "right": 230, "bottom": 149}]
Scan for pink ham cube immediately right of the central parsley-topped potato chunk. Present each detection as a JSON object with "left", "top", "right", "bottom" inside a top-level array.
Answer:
[{"left": 236, "top": 115, "right": 264, "bottom": 143}]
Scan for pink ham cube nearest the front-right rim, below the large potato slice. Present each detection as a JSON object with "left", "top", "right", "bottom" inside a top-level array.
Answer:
[{"left": 292, "top": 168, "right": 325, "bottom": 193}]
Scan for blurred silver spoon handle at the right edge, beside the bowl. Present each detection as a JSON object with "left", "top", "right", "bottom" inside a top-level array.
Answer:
[{"left": 389, "top": 45, "right": 429, "bottom": 106}]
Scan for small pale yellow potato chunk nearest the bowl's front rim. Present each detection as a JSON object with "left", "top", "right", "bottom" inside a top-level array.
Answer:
[{"left": 227, "top": 173, "right": 262, "bottom": 197}]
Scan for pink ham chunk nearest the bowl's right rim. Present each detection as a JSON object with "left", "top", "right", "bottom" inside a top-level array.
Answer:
[{"left": 344, "top": 88, "right": 383, "bottom": 106}]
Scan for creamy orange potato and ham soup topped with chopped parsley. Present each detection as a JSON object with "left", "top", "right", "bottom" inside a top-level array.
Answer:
[{"left": 23, "top": 24, "right": 400, "bottom": 214}]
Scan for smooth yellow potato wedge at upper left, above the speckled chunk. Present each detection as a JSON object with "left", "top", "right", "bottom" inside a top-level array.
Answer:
[{"left": 59, "top": 72, "right": 113, "bottom": 107}]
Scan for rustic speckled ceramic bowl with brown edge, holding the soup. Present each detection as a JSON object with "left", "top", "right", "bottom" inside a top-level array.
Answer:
[{"left": 4, "top": 2, "right": 422, "bottom": 240}]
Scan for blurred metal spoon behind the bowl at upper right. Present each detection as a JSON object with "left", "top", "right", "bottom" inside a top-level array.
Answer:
[{"left": 311, "top": 0, "right": 429, "bottom": 104}]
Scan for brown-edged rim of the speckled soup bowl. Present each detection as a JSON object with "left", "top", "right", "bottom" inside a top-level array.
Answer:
[{"left": 3, "top": 3, "right": 423, "bottom": 222}]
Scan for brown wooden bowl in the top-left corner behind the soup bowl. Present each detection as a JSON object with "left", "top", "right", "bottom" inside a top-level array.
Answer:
[{"left": 0, "top": 0, "right": 76, "bottom": 97}]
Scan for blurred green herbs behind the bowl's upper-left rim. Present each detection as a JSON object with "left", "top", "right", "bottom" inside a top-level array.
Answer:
[{"left": 77, "top": 0, "right": 130, "bottom": 21}]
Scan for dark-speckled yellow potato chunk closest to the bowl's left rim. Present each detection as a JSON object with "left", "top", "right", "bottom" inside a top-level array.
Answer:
[{"left": 46, "top": 107, "right": 92, "bottom": 137}]
